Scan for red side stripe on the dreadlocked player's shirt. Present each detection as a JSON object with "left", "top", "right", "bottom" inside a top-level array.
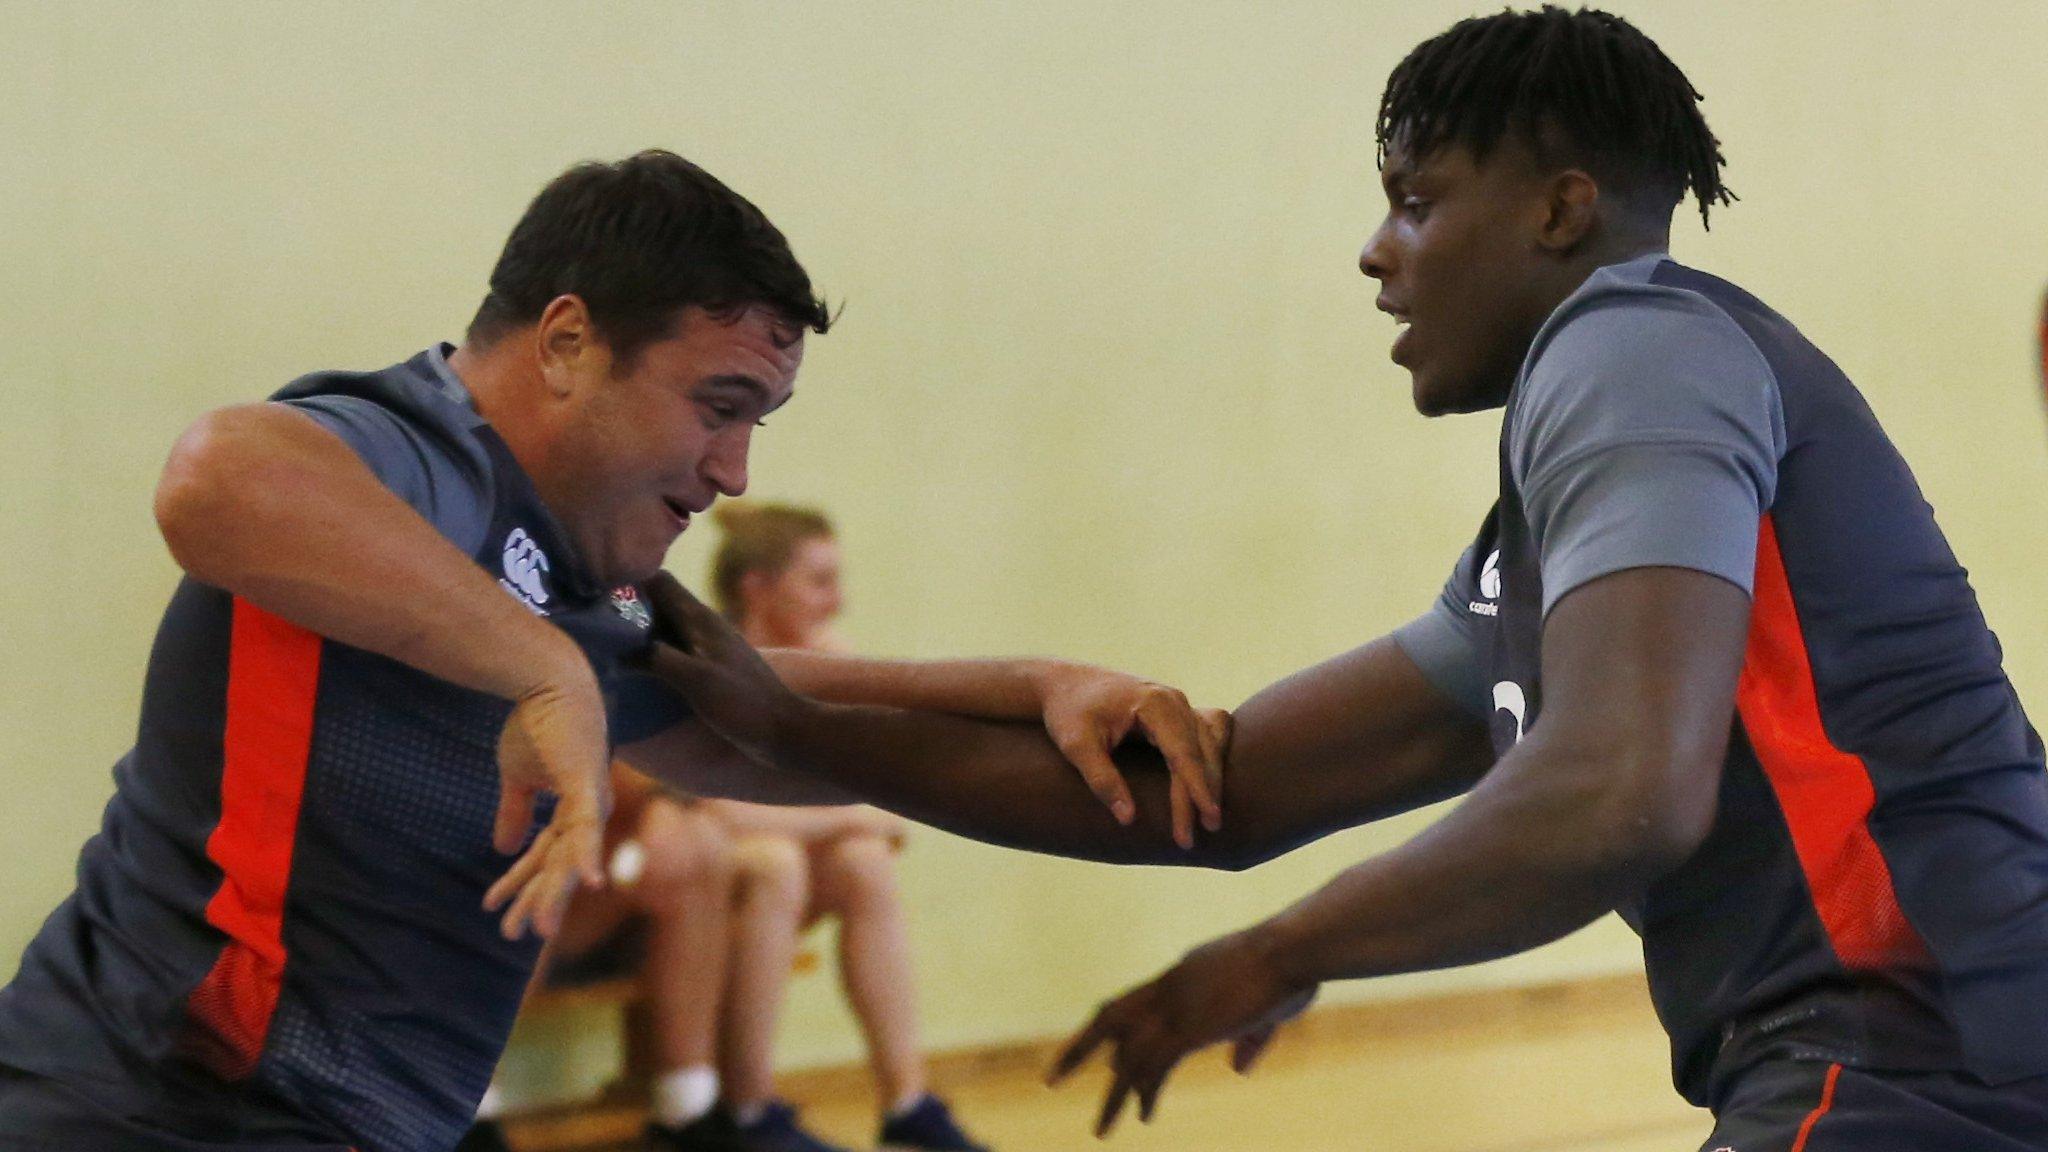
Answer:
[{"left": 1735, "top": 515, "right": 1927, "bottom": 970}]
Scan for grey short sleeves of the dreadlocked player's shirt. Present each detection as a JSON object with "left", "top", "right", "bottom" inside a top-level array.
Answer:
[{"left": 1395, "top": 252, "right": 1786, "bottom": 715}]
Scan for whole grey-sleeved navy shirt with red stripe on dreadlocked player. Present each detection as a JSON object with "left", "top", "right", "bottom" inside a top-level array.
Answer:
[{"left": 1397, "top": 254, "right": 2048, "bottom": 1105}]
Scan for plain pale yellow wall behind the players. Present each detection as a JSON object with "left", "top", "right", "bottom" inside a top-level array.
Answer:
[{"left": 0, "top": 0, "right": 2048, "bottom": 1062}]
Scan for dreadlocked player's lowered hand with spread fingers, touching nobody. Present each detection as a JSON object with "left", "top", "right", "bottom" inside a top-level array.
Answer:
[{"left": 1047, "top": 929, "right": 1315, "bottom": 1136}]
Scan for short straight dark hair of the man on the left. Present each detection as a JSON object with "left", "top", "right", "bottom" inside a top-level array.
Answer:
[{"left": 469, "top": 150, "right": 831, "bottom": 363}]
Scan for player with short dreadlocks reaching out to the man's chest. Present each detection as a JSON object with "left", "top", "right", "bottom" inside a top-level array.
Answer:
[{"left": 655, "top": 8, "right": 2048, "bottom": 1152}]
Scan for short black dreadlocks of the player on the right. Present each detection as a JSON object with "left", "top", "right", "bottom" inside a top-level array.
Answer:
[{"left": 1376, "top": 4, "right": 1735, "bottom": 221}]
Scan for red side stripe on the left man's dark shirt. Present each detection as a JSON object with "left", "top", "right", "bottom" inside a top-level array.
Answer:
[{"left": 186, "top": 599, "right": 319, "bottom": 1080}]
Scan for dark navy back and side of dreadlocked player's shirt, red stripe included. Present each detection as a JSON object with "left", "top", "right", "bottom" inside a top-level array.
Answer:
[{"left": 1632, "top": 260, "right": 2048, "bottom": 1099}]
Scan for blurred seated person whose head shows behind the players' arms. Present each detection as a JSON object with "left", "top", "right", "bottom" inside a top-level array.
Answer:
[{"left": 702, "top": 502, "right": 995, "bottom": 1152}]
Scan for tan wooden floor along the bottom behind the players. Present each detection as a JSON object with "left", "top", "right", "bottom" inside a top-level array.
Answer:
[{"left": 512, "top": 978, "right": 1710, "bottom": 1152}]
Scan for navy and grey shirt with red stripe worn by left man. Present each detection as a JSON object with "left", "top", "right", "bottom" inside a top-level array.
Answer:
[{"left": 0, "top": 346, "right": 686, "bottom": 1152}]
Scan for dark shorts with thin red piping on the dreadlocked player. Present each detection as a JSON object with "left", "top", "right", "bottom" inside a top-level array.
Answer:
[{"left": 1700, "top": 1060, "right": 2048, "bottom": 1152}]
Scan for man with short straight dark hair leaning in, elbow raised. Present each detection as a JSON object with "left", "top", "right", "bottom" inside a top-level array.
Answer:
[{"left": 0, "top": 152, "right": 1214, "bottom": 1152}]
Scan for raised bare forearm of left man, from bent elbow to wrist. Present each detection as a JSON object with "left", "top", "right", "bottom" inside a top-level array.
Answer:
[{"left": 156, "top": 404, "right": 594, "bottom": 699}]
